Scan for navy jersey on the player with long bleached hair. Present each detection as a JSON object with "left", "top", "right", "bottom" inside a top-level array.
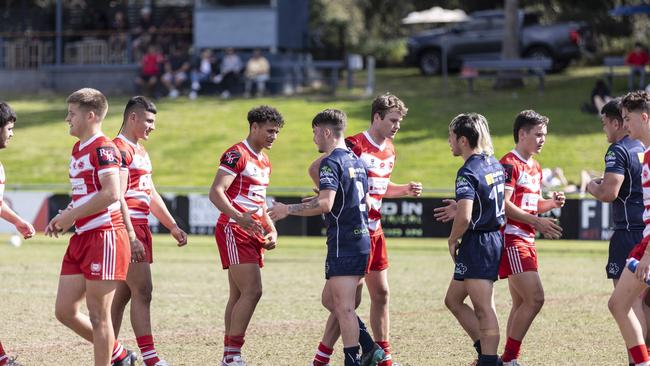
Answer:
[{"left": 456, "top": 154, "right": 505, "bottom": 231}]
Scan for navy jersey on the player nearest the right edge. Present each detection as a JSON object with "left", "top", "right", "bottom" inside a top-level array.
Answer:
[{"left": 605, "top": 136, "right": 644, "bottom": 230}]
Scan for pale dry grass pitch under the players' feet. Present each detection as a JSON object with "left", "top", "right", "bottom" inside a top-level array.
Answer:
[{"left": 0, "top": 235, "right": 627, "bottom": 366}]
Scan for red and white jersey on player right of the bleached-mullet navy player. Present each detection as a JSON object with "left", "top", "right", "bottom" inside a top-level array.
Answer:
[{"left": 501, "top": 150, "right": 542, "bottom": 243}]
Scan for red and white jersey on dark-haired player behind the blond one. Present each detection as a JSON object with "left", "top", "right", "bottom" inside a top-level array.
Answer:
[{"left": 113, "top": 135, "right": 152, "bottom": 225}]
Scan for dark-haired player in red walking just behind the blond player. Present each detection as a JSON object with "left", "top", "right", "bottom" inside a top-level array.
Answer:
[{"left": 111, "top": 96, "right": 187, "bottom": 366}]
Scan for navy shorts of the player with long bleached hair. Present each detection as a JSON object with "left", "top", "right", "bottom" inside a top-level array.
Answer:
[{"left": 454, "top": 231, "right": 503, "bottom": 281}]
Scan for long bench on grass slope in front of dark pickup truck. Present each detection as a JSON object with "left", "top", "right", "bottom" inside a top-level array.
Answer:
[{"left": 460, "top": 58, "right": 553, "bottom": 95}]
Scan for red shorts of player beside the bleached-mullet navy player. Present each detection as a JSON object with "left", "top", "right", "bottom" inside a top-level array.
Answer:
[{"left": 499, "top": 234, "right": 537, "bottom": 278}]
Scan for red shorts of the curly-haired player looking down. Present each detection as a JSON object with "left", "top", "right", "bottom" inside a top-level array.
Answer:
[{"left": 214, "top": 223, "right": 264, "bottom": 269}]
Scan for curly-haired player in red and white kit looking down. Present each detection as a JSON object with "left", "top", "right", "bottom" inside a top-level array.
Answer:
[{"left": 209, "top": 106, "right": 284, "bottom": 366}]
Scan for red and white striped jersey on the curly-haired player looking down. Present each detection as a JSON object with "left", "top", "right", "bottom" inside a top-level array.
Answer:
[{"left": 218, "top": 140, "right": 271, "bottom": 224}]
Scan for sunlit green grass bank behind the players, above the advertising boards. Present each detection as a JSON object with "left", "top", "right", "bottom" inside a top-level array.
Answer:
[{"left": 0, "top": 68, "right": 624, "bottom": 191}]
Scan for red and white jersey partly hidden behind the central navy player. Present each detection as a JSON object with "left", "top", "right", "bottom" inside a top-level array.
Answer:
[{"left": 345, "top": 131, "right": 396, "bottom": 234}]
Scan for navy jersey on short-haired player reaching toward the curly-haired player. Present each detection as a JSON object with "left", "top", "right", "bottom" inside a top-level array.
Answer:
[{"left": 319, "top": 148, "right": 370, "bottom": 257}]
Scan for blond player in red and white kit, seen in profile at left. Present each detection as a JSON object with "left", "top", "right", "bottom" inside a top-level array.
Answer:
[{"left": 45, "top": 88, "right": 133, "bottom": 366}]
